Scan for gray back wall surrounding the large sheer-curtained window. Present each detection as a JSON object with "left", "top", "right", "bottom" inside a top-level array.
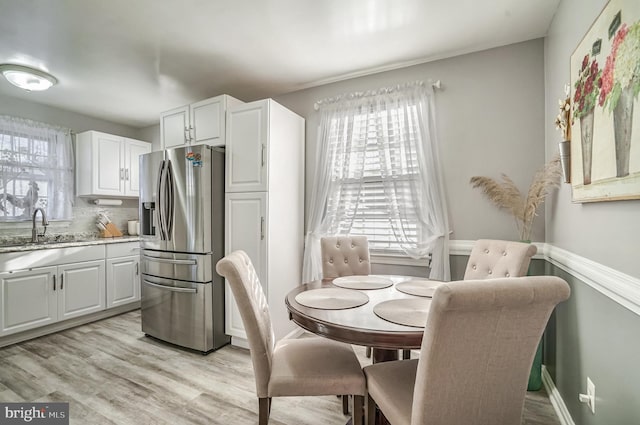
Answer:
[{"left": 275, "top": 39, "right": 544, "bottom": 241}]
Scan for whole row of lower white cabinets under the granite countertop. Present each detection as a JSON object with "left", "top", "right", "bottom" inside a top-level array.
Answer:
[{"left": 0, "top": 241, "right": 140, "bottom": 338}]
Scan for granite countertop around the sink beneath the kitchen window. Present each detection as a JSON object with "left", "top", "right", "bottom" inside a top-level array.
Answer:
[{"left": 0, "top": 234, "right": 140, "bottom": 254}]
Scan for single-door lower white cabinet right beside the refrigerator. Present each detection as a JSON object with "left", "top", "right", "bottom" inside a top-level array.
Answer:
[{"left": 106, "top": 242, "right": 140, "bottom": 308}]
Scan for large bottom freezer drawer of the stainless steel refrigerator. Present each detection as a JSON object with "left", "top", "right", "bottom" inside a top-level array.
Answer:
[{"left": 141, "top": 275, "right": 229, "bottom": 352}]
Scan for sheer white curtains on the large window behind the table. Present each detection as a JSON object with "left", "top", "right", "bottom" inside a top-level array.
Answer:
[{"left": 303, "top": 83, "right": 450, "bottom": 281}]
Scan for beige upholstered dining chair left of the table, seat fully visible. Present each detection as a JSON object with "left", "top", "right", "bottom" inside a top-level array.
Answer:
[{"left": 216, "top": 251, "right": 366, "bottom": 425}]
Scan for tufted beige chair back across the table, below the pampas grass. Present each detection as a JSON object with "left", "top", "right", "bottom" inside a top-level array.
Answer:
[{"left": 463, "top": 239, "right": 538, "bottom": 280}]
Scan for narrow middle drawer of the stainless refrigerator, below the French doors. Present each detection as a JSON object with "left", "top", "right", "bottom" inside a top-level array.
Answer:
[{"left": 141, "top": 249, "right": 213, "bottom": 283}]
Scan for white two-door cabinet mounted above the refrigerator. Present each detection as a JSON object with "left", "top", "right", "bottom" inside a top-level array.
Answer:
[{"left": 160, "top": 94, "right": 242, "bottom": 149}]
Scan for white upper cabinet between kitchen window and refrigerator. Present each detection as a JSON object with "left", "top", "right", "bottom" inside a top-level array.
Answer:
[{"left": 76, "top": 131, "right": 151, "bottom": 198}]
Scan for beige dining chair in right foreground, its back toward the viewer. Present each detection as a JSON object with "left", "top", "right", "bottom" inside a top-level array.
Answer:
[{"left": 364, "top": 276, "right": 569, "bottom": 425}]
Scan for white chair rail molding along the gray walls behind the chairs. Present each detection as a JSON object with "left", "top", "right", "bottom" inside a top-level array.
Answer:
[{"left": 449, "top": 240, "right": 640, "bottom": 316}]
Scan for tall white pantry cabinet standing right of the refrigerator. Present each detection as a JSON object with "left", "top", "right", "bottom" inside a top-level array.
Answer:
[{"left": 225, "top": 99, "right": 304, "bottom": 345}]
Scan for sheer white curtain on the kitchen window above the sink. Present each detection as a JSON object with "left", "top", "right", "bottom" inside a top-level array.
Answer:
[{"left": 0, "top": 115, "right": 74, "bottom": 221}]
